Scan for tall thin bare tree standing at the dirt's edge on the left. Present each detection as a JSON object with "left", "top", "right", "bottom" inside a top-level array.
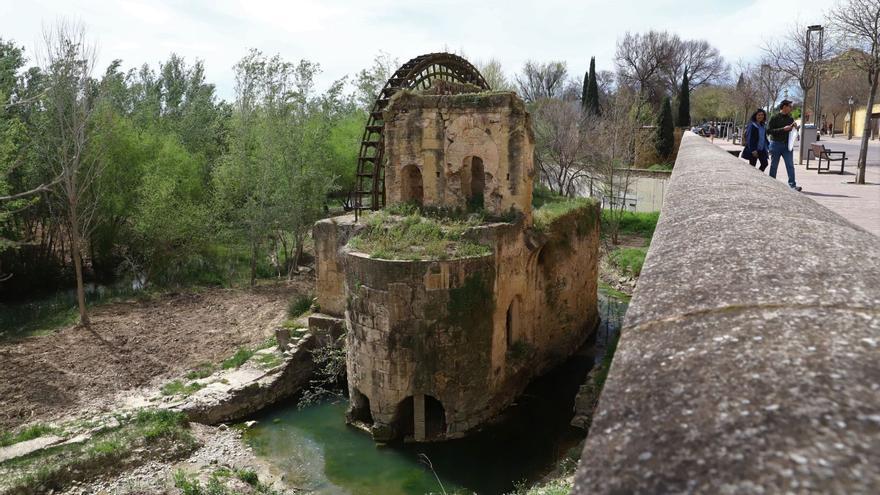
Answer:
[{"left": 40, "top": 21, "right": 100, "bottom": 326}]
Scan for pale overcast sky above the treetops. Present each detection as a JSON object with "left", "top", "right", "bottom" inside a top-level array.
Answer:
[{"left": 0, "top": 0, "right": 834, "bottom": 99}]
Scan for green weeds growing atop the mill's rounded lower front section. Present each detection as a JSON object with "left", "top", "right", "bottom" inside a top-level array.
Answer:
[{"left": 349, "top": 211, "right": 492, "bottom": 260}]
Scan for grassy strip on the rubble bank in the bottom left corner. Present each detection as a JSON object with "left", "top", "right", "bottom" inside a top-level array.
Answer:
[{"left": 0, "top": 410, "right": 197, "bottom": 493}]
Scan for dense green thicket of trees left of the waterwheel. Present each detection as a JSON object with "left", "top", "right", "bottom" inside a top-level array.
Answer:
[{"left": 0, "top": 35, "right": 366, "bottom": 326}]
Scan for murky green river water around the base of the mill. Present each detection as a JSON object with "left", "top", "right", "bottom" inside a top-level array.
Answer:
[{"left": 246, "top": 291, "right": 627, "bottom": 495}]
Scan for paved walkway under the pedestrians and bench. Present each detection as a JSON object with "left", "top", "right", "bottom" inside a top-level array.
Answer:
[{"left": 715, "top": 137, "right": 880, "bottom": 237}]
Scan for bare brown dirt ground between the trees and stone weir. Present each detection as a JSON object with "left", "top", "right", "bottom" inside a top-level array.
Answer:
[{"left": 0, "top": 274, "right": 314, "bottom": 429}]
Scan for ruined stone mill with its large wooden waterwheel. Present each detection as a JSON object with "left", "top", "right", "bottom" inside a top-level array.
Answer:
[{"left": 310, "top": 53, "right": 599, "bottom": 442}]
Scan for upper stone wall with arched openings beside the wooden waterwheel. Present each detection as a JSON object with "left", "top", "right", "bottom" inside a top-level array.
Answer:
[{"left": 385, "top": 91, "right": 534, "bottom": 216}]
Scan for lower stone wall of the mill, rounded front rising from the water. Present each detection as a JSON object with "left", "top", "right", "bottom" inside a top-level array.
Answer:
[{"left": 345, "top": 205, "right": 599, "bottom": 440}]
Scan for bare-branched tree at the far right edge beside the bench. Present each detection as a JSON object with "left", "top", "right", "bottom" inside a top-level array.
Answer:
[{"left": 829, "top": 0, "right": 880, "bottom": 184}]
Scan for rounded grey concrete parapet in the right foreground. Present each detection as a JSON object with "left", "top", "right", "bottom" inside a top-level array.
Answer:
[{"left": 574, "top": 133, "right": 880, "bottom": 495}]
